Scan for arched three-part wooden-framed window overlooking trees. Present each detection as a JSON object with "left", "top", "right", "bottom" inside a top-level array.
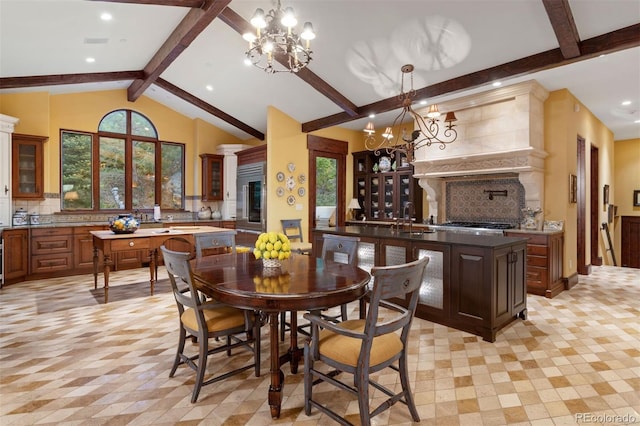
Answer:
[{"left": 60, "top": 109, "right": 184, "bottom": 211}]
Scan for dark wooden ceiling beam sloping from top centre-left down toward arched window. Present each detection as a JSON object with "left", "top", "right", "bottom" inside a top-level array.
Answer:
[{"left": 127, "top": 0, "right": 231, "bottom": 102}]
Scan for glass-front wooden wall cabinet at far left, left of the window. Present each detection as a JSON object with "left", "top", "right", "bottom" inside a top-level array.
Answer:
[{"left": 11, "top": 133, "right": 47, "bottom": 199}]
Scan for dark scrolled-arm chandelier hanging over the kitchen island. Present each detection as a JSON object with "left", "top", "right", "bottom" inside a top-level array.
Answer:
[{"left": 364, "top": 64, "right": 458, "bottom": 163}]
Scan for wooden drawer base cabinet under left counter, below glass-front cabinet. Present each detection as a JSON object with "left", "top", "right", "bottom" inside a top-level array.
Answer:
[{"left": 29, "top": 227, "right": 73, "bottom": 277}]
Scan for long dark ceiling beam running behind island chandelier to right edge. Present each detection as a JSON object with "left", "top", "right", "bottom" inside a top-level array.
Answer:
[{"left": 302, "top": 24, "right": 640, "bottom": 133}]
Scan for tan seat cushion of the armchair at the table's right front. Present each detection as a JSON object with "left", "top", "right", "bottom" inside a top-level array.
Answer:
[{"left": 318, "top": 320, "right": 402, "bottom": 367}]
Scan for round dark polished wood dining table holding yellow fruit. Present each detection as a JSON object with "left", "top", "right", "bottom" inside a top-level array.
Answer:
[{"left": 190, "top": 253, "right": 371, "bottom": 419}]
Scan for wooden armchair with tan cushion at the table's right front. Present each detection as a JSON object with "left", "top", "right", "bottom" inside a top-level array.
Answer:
[{"left": 304, "top": 257, "right": 429, "bottom": 426}]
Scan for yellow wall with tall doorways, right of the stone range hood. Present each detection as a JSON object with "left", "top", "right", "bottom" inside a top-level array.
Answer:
[{"left": 544, "top": 89, "right": 615, "bottom": 277}]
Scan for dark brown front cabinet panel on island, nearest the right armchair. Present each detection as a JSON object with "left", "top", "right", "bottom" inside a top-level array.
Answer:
[{"left": 450, "top": 246, "right": 492, "bottom": 341}]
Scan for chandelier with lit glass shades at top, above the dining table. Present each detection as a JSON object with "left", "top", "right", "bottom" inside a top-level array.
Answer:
[{"left": 242, "top": 0, "right": 316, "bottom": 74}]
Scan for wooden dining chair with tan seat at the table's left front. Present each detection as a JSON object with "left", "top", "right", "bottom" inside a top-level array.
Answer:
[{"left": 160, "top": 245, "right": 262, "bottom": 403}]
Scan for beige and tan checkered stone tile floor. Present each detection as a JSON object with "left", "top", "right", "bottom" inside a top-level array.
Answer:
[{"left": 0, "top": 267, "right": 640, "bottom": 426}]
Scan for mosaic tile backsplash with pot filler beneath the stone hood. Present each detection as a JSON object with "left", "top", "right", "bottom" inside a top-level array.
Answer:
[{"left": 445, "top": 177, "right": 525, "bottom": 225}]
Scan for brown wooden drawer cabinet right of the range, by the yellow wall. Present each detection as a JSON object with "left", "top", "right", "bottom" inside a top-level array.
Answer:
[{"left": 505, "top": 231, "right": 565, "bottom": 298}]
